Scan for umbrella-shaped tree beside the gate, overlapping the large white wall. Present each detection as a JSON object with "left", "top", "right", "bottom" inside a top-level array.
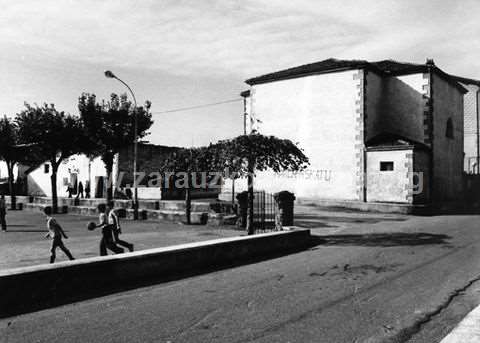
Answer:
[{"left": 215, "top": 133, "right": 309, "bottom": 235}]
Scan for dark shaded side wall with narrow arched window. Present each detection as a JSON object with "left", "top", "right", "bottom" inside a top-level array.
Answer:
[{"left": 432, "top": 74, "right": 463, "bottom": 202}]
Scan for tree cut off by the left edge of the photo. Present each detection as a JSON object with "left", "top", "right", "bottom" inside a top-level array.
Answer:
[{"left": 0, "top": 116, "right": 23, "bottom": 209}]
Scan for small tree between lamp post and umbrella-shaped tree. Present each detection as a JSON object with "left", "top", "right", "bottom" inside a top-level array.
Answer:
[{"left": 159, "top": 147, "right": 211, "bottom": 224}]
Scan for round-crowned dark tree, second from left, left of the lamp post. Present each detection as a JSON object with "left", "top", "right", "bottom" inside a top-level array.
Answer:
[{"left": 15, "top": 103, "right": 88, "bottom": 213}]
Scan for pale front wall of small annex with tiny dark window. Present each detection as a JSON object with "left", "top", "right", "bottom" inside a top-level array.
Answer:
[{"left": 367, "top": 149, "right": 413, "bottom": 203}]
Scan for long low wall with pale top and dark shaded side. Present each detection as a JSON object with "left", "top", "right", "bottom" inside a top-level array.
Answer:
[{"left": 0, "top": 230, "right": 310, "bottom": 317}]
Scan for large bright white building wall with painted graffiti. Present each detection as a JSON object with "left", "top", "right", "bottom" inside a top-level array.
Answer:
[{"left": 251, "top": 70, "right": 360, "bottom": 200}]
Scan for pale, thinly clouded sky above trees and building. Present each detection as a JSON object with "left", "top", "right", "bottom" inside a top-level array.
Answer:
[{"left": 0, "top": 0, "right": 480, "bottom": 146}]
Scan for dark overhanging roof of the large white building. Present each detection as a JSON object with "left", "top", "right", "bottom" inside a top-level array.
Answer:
[{"left": 245, "top": 58, "right": 467, "bottom": 93}]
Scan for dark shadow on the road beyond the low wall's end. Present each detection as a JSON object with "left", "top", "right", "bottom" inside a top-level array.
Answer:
[{"left": 312, "top": 232, "right": 451, "bottom": 247}]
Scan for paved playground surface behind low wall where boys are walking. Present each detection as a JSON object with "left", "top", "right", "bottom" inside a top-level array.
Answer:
[{"left": 0, "top": 211, "right": 240, "bottom": 270}]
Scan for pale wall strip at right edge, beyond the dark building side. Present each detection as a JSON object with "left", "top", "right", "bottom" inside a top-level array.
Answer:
[{"left": 462, "top": 84, "right": 480, "bottom": 173}]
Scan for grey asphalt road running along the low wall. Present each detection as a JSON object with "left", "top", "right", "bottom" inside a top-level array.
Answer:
[{"left": 0, "top": 211, "right": 480, "bottom": 343}]
